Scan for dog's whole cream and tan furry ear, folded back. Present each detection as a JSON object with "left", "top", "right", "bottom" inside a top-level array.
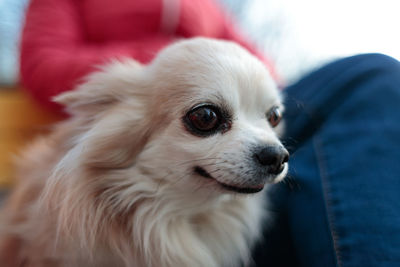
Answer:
[{"left": 55, "top": 60, "right": 154, "bottom": 168}]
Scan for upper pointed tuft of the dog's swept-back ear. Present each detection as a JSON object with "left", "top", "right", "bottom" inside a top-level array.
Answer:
[{"left": 53, "top": 59, "right": 143, "bottom": 115}]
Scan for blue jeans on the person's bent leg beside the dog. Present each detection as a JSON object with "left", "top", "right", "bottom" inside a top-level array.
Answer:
[{"left": 254, "top": 54, "right": 400, "bottom": 267}]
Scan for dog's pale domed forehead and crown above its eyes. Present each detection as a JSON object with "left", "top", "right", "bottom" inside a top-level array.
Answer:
[{"left": 152, "top": 39, "right": 279, "bottom": 115}]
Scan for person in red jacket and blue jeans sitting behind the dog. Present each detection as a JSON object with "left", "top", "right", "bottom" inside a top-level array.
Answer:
[{"left": 21, "top": 0, "right": 400, "bottom": 267}]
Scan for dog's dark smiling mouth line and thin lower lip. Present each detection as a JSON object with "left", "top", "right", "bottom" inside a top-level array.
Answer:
[{"left": 194, "top": 166, "right": 287, "bottom": 194}]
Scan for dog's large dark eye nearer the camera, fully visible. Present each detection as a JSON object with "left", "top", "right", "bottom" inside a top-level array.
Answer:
[{"left": 187, "top": 106, "right": 219, "bottom": 132}]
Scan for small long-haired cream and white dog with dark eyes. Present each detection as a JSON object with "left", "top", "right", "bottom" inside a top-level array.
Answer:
[{"left": 0, "top": 38, "right": 289, "bottom": 267}]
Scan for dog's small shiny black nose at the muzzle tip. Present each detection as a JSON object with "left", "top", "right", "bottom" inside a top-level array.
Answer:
[{"left": 254, "top": 146, "right": 289, "bottom": 174}]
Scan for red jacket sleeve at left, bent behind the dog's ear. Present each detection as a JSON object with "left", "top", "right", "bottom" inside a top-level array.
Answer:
[{"left": 20, "top": 0, "right": 172, "bottom": 111}]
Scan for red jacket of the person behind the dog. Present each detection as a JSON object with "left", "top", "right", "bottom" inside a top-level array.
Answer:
[{"left": 20, "top": 0, "right": 276, "bottom": 111}]
